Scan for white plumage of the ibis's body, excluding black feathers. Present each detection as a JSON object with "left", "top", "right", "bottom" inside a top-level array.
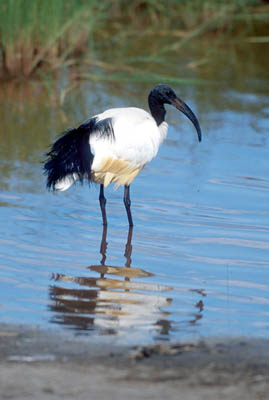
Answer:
[{"left": 55, "top": 107, "right": 168, "bottom": 191}]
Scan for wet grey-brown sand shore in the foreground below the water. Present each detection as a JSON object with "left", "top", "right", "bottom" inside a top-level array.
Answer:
[{"left": 0, "top": 324, "right": 269, "bottom": 400}]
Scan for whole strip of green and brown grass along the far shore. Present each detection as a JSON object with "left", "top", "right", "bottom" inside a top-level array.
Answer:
[{"left": 0, "top": 0, "right": 269, "bottom": 79}]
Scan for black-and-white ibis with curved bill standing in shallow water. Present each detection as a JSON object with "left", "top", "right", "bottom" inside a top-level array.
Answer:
[{"left": 44, "top": 84, "right": 199, "bottom": 226}]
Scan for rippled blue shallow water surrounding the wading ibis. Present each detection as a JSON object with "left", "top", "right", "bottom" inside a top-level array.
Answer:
[{"left": 0, "top": 43, "right": 269, "bottom": 343}]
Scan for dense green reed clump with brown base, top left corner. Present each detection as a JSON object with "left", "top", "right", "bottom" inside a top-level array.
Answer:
[{"left": 0, "top": 0, "right": 107, "bottom": 77}]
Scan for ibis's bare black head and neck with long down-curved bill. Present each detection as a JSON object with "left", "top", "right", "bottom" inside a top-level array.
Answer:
[{"left": 148, "top": 83, "right": 202, "bottom": 142}]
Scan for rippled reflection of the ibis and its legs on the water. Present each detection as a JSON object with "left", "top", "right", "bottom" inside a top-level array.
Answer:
[{"left": 49, "top": 227, "right": 205, "bottom": 339}]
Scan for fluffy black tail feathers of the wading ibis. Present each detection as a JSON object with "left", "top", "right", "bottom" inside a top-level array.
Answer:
[{"left": 44, "top": 120, "right": 95, "bottom": 190}]
